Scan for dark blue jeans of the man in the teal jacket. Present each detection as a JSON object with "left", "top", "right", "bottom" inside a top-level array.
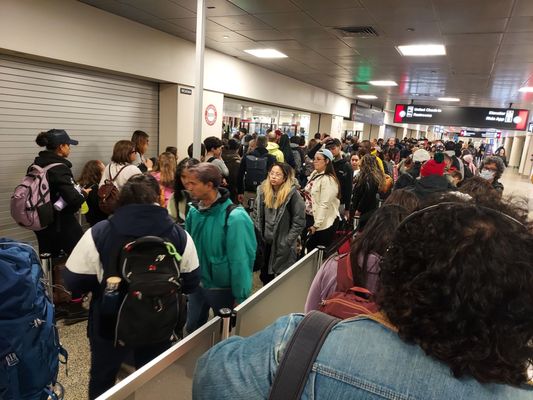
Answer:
[{"left": 186, "top": 286, "right": 235, "bottom": 333}]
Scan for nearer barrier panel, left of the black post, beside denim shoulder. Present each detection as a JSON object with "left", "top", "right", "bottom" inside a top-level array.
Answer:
[{"left": 97, "top": 317, "right": 222, "bottom": 400}]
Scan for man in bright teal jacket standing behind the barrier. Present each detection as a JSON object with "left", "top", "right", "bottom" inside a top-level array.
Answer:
[{"left": 185, "top": 163, "right": 256, "bottom": 333}]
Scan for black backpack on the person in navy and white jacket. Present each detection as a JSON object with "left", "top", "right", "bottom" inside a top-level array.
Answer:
[{"left": 100, "top": 236, "right": 187, "bottom": 348}]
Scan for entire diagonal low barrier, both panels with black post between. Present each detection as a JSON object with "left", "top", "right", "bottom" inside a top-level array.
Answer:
[{"left": 97, "top": 249, "right": 323, "bottom": 400}]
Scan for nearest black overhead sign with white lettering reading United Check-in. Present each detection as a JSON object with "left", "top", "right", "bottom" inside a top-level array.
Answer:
[{"left": 394, "top": 104, "right": 529, "bottom": 131}]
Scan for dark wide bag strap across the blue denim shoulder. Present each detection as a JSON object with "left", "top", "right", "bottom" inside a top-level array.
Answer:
[{"left": 269, "top": 311, "right": 340, "bottom": 400}]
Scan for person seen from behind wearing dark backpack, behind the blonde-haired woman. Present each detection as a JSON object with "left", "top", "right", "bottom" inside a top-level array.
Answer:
[{"left": 237, "top": 136, "right": 276, "bottom": 209}]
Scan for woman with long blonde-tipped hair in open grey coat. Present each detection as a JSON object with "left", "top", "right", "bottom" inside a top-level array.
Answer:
[{"left": 253, "top": 162, "right": 305, "bottom": 285}]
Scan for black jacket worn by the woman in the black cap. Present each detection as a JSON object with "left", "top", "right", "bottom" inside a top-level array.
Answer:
[{"left": 34, "top": 150, "right": 85, "bottom": 214}]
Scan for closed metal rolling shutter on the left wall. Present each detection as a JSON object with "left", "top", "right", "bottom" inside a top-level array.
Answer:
[{"left": 0, "top": 54, "right": 159, "bottom": 243}]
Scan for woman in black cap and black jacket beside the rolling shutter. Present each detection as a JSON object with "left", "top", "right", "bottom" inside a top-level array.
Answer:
[{"left": 34, "top": 129, "right": 87, "bottom": 257}]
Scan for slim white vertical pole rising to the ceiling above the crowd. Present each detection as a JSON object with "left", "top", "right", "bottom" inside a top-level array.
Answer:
[{"left": 193, "top": 0, "right": 205, "bottom": 160}]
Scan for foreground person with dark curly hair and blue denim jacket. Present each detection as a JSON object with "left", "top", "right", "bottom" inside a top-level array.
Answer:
[{"left": 193, "top": 203, "right": 533, "bottom": 400}]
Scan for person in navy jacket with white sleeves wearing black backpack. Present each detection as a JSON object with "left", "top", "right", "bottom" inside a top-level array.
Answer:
[{"left": 65, "top": 175, "right": 199, "bottom": 399}]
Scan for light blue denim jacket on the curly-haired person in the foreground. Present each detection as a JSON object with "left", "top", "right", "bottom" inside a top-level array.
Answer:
[{"left": 193, "top": 314, "right": 533, "bottom": 400}]
